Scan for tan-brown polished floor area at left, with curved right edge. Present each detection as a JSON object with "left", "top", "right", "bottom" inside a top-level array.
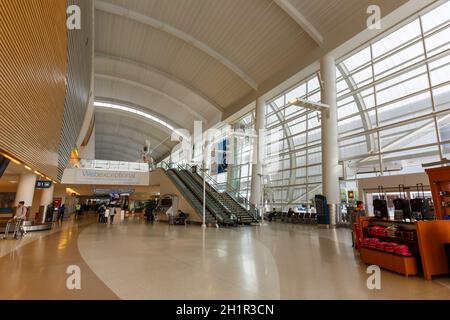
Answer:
[{"left": 0, "top": 217, "right": 118, "bottom": 300}]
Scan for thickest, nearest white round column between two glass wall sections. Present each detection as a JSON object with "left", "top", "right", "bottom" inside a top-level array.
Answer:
[{"left": 320, "top": 55, "right": 340, "bottom": 204}]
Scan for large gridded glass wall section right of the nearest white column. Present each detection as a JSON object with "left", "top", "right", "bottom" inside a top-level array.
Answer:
[{"left": 337, "top": 1, "right": 450, "bottom": 177}]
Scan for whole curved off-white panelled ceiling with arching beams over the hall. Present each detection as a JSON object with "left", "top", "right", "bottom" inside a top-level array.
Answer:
[{"left": 95, "top": 0, "right": 406, "bottom": 161}]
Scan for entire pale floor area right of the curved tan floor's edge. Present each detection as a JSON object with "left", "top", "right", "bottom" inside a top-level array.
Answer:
[{"left": 78, "top": 222, "right": 450, "bottom": 299}]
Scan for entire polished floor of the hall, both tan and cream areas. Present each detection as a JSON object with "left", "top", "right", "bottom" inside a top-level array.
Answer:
[{"left": 0, "top": 217, "right": 450, "bottom": 300}]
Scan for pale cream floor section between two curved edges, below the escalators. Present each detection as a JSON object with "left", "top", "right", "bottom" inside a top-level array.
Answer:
[{"left": 78, "top": 223, "right": 280, "bottom": 299}]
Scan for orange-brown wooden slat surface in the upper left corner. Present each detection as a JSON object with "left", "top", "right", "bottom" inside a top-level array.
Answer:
[{"left": 0, "top": 0, "right": 67, "bottom": 179}]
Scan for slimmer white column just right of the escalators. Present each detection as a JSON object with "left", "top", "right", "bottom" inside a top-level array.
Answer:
[{"left": 250, "top": 98, "right": 266, "bottom": 207}]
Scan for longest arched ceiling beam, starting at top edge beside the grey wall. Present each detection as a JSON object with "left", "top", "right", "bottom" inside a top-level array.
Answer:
[{"left": 95, "top": 0, "right": 258, "bottom": 90}]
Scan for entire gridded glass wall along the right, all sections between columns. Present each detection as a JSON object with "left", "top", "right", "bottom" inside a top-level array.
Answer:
[{"left": 160, "top": 1, "right": 450, "bottom": 210}]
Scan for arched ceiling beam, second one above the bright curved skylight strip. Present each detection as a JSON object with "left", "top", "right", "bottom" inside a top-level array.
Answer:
[{"left": 95, "top": 51, "right": 224, "bottom": 112}]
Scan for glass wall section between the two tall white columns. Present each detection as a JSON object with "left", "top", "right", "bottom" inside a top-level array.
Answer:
[{"left": 264, "top": 74, "right": 322, "bottom": 210}]
